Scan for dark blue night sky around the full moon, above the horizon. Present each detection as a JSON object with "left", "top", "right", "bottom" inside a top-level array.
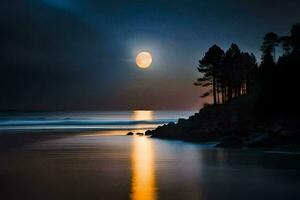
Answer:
[{"left": 0, "top": 0, "right": 300, "bottom": 110}]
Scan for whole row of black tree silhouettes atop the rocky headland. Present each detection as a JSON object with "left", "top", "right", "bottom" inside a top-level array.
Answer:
[{"left": 195, "top": 24, "right": 300, "bottom": 116}]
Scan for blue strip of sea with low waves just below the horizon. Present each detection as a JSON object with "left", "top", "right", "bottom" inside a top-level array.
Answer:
[{"left": 0, "top": 110, "right": 193, "bottom": 132}]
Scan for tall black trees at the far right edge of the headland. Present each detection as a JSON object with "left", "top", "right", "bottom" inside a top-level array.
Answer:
[{"left": 257, "top": 24, "right": 300, "bottom": 115}]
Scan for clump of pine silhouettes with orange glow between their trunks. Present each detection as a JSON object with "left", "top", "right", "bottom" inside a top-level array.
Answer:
[{"left": 195, "top": 44, "right": 257, "bottom": 104}]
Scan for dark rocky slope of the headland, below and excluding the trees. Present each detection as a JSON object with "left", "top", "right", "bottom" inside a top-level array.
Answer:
[{"left": 149, "top": 96, "right": 300, "bottom": 150}]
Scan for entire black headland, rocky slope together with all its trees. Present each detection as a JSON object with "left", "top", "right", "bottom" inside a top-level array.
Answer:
[{"left": 147, "top": 24, "right": 300, "bottom": 149}]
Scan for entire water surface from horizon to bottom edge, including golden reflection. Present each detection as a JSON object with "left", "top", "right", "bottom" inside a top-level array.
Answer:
[{"left": 0, "top": 111, "right": 300, "bottom": 200}]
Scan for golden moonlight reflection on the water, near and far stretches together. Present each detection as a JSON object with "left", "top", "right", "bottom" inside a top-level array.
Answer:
[{"left": 131, "top": 111, "right": 157, "bottom": 200}]
